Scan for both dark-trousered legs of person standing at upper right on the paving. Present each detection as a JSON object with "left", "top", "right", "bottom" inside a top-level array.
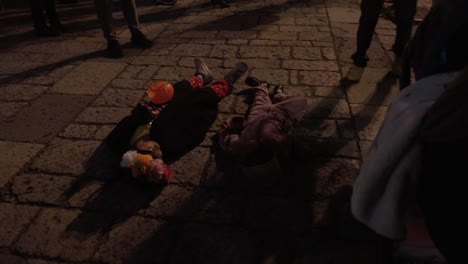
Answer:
[{"left": 351, "top": 0, "right": 417, "bottom": 67}]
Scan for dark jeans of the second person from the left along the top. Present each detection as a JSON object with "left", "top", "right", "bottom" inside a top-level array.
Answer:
[{"left": 94, "top": 0, "right": 140, "bottom": 41}]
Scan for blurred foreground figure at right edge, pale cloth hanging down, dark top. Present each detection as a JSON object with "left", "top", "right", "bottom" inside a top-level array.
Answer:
[{"left": 352, "top": 0, "right": 468, "bottom": 263}]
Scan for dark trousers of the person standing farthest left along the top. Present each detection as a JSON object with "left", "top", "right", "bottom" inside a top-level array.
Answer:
[{"left": 30, "top": 0, "right": 60, "bottom": 31}]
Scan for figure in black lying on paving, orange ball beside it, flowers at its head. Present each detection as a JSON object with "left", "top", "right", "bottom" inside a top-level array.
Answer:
[{"left": 121, "top": 59, "right": 248, "bottom": 183}]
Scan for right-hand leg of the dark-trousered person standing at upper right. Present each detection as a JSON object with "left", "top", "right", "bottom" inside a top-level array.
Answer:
[{"left": 392, "top": 0, "right": 417, "bottom": 57}]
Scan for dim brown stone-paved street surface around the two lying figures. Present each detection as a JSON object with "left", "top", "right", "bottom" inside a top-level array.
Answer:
[{"left": 0, "top": 0, "right": 429, "bottom": 264}]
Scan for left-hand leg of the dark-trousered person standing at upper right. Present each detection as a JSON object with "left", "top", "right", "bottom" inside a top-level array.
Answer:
[{"left": 352, "top": 0, "right": 383, "bottom": 67}]
